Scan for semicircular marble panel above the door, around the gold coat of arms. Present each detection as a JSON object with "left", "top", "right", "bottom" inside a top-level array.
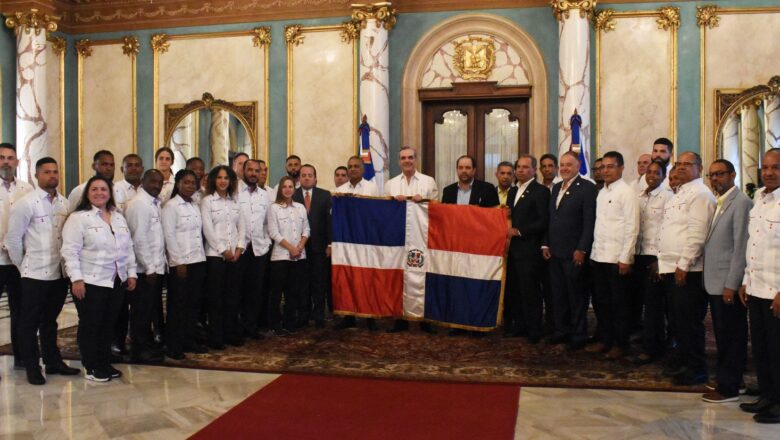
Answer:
[{"left": 421, "top": 33, "right": 530, "bottom": 89}]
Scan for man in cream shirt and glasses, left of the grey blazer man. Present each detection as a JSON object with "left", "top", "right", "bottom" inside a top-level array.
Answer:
[{"left": 658, "top": 151, "right": 716, "bottom": 385}]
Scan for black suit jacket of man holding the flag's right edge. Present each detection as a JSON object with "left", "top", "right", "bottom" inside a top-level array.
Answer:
[{"left": 506, "top": 180, "right": 550, "bottom": 259}]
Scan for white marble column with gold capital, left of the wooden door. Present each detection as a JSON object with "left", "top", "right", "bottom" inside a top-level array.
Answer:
[{"left": 352, "top": 2, "right": 394, "bottom": 193}]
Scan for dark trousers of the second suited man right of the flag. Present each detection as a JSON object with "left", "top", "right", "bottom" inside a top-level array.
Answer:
[{"left": 550, "top": 257, "right": 588, "bottom": 344}]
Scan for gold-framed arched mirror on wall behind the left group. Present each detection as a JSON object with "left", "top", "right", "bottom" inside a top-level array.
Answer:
[{"left": 164, "top": 93, "right": 257, "bottom": 173}]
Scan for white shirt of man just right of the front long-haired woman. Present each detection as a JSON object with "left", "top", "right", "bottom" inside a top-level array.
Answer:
[{"left": 125, "top": 188, "right": 168, "bottom": 275}]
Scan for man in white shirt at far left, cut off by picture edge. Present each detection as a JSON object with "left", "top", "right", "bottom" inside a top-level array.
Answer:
[{"left": 0, "top": 143, "right": 33, "bottom": 369}]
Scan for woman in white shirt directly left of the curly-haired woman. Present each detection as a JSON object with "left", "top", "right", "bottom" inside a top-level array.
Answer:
[{"left": 162, "top": 170, "right": 208, "bottom": 359}]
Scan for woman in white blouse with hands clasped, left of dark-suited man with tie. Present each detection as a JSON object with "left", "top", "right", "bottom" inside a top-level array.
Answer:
[{"left": 268, "top": 176, "right": 310, "bottom": 336}]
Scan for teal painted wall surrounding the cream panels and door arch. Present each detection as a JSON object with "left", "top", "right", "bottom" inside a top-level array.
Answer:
[{"left": 0, "top": 0, "right": 780, "bottom": 188}]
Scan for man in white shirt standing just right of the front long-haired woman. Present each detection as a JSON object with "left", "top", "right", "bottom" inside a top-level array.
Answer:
[{"left": 125, "top": 170, "right": 168, "bottom": 363}]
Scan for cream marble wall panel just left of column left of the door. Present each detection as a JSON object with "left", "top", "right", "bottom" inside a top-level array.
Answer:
[{"left": 288, "top": 26, "right": 358, "bottom": 189}]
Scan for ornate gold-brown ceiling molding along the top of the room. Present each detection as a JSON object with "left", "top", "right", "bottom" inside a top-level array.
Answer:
[{"left": 1, "top": 0, "right": 692, "bottom": 34}]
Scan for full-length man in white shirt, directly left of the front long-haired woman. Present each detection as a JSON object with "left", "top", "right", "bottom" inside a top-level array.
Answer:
[{"left": 0, "top": 156, "right": 79, "bottom": 385}]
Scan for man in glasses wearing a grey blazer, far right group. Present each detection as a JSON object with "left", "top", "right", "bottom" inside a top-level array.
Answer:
[{"left": 702, "top": 159, "right": 753, "bottom": 403}]
